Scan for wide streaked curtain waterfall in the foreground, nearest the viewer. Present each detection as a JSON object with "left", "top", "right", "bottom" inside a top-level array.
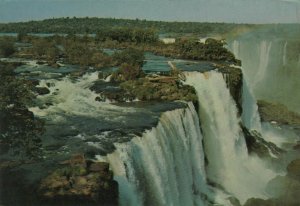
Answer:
[{"left": 107, "top": 103, "right": 217, "bottom": 206}]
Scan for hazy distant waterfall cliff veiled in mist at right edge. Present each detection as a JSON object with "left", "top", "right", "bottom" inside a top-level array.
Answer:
[{"left": 228, "top": 38, "right": 300, "bottom": 113}]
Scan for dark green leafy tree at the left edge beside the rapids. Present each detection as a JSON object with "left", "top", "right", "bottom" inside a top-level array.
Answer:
[{"left": 0, "top": 62, "right": 43, "bottom": 157}]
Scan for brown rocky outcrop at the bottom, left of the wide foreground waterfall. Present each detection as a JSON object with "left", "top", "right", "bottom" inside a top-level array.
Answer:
[{"left": 38, "top": 155, "right": 118, "bottom": 206}]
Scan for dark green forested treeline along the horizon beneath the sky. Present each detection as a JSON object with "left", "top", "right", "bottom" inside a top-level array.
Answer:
[{"left": 0, "top": 17, "right": 254, "bottom": 36}]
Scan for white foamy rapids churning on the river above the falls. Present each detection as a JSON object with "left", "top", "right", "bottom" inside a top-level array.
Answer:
[{"left": 30, "top": 72, "right": 135, "bottom": 121}]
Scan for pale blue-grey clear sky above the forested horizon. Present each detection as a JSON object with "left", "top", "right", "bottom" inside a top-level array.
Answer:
[{"left": 0, "top": 0, "right": 300, "bottom": 23}]
